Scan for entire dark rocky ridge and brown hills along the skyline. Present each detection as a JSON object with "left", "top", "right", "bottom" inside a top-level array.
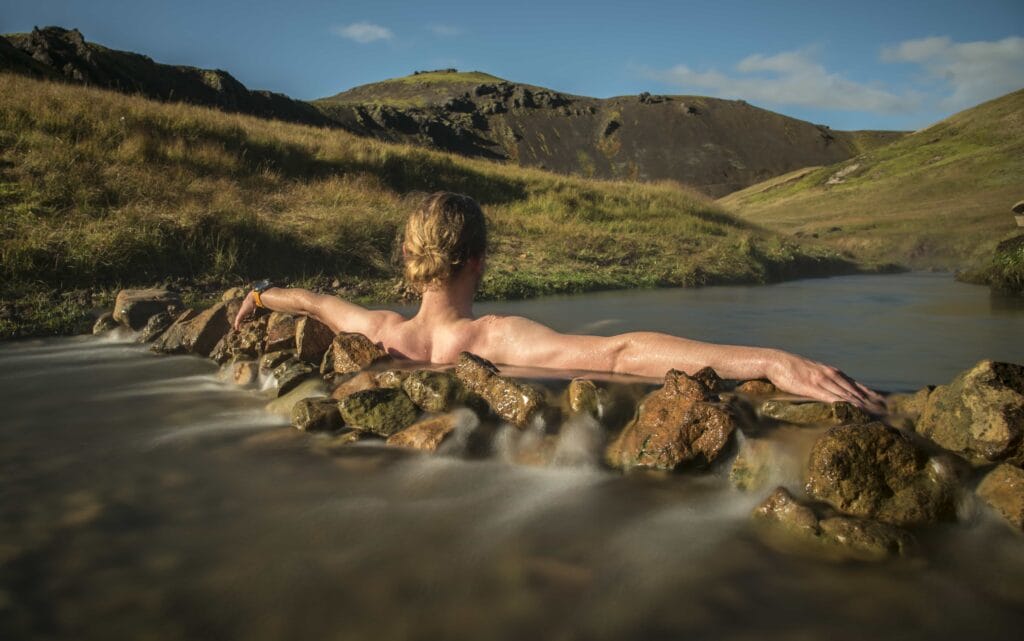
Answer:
[{"left": 6, "top": 27, "right": 903, "bottom": 197}]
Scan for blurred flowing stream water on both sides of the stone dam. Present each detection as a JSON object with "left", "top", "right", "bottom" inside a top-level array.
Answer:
[{"left": 0, "top": 274, "right": 1024, "bottom": 641}]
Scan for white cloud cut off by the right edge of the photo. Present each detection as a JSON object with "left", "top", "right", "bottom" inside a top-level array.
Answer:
[{"left": 881, "top": 37, "right": 1024, "bottom": 110}]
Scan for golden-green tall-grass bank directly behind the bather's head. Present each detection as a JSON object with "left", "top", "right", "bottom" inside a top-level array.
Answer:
[{"left": 0, "top": 74, "right": 868, "bottom": 337}]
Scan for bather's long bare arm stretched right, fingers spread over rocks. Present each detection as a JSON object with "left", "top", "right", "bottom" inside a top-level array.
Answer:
[{"left": 476, "top": 316, "right": 884, "bottom": 410}]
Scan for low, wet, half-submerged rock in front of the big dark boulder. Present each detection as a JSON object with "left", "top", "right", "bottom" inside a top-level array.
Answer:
[{"left": 753, "top": 487, "right": 918, "bottom": 561}]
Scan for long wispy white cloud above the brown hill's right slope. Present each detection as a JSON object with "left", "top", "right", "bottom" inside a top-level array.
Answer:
[{"left": 646, "top": 50, "right": 921, "bottom": 114}]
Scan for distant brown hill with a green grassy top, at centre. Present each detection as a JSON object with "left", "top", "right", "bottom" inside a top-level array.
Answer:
[{"left": 314, "top": 70, "right": 902, "bottom": 196}]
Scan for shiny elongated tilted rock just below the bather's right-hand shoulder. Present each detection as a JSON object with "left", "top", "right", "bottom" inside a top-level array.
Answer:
[{"left": 455, "top": 351, "right": 544, "bottom": 427}]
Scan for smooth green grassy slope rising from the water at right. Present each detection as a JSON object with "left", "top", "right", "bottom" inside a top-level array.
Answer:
[{"left": 719, "top": 90, "right": 1024, "bottom": 268}]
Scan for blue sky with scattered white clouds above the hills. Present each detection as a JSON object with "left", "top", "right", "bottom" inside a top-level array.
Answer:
[{"left": 6, "top": 0, "right": 1024, "bottom": 129}]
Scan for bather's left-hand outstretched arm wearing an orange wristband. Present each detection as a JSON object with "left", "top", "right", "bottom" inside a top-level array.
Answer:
[{"left": 234, "top": 287, "right": 398, "bottom": 333}]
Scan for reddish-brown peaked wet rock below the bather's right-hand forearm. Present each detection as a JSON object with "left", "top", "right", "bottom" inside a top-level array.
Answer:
[{"left": 605, "top": 370, "right": 737, "bottom": 470}]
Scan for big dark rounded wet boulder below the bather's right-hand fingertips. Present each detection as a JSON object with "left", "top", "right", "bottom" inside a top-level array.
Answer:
[{"left": 807, "top": 423, "right": 955, "bottom": 525}]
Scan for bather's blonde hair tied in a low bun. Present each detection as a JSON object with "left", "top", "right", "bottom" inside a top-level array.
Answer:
[{"left": 401, "top": 191, "right": 487, "bottom": 292}]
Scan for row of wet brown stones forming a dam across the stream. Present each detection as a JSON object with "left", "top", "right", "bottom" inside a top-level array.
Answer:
[{"left": 94, "top": 290, "right": 1024, "bottom": 561}]
